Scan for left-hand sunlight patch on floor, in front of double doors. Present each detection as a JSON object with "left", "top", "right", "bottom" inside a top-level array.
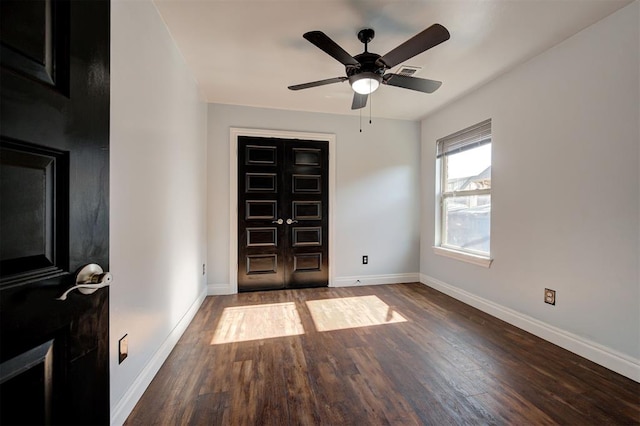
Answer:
[{"left": 211, "top": 302, "right": 304, "bottom": 345}]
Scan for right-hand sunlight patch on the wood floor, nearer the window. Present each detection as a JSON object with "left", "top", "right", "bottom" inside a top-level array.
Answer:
[{"left": 307, "top": 296, "right": 407, "bottom": 331}]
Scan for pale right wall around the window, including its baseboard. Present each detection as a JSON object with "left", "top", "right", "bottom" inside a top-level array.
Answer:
[{"left": 420, "top": 1, "right": 640, "bottom": 380}]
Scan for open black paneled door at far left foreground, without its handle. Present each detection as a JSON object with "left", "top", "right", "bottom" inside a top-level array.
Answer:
[{"left": 0, "top": 0, "right": 110, "bottom": 424}]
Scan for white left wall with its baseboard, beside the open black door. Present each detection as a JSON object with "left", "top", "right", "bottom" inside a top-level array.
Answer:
[{"left": 110, "top": 1, "right": 207, "bottom": 424}]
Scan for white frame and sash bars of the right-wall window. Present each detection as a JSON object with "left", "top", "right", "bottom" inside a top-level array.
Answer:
[{"left": 433, "top": 119, "right": 493, "bottom": 268}]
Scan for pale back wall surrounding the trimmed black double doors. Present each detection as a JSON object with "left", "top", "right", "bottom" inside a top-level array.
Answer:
[{"left": 208, "top": 104, "right": 420, "bottom": 293}]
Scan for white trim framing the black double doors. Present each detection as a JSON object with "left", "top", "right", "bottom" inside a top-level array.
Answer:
[{"left": 229, "top": 127, "right": 336, "bottom": 294}]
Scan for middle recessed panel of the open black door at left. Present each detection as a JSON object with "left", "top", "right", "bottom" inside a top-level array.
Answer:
[{"left": 0, "top": 138, "right": 69, "bottom": 287}]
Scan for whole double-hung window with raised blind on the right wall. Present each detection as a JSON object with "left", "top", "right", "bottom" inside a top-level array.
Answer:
[{"left": 435, "top": 120, "right": 491, "bottom": 267}]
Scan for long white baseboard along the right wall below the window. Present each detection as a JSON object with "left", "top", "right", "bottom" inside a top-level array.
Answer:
[{"left": 420, "top": 274, "right": 640, "bottom": 382}]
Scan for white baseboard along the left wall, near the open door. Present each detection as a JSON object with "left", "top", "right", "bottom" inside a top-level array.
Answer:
[{"left": 111, "top": 290, "right": 206, "bottom": 426}]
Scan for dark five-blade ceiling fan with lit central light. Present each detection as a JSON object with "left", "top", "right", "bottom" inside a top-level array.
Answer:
[{"left": 289, "top": 24, "right": 450, "bottom": 109}]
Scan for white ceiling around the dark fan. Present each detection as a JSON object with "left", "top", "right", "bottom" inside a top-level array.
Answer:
[{"left": 155, "top": 0, "right": 632, "bottom": 120}]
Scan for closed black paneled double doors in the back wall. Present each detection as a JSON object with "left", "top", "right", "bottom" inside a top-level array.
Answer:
[{"left": 238, "top": 136, "right": 329, "bottom": 291}]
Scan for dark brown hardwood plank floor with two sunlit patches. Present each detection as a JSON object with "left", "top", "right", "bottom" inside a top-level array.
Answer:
[{"left": 126, "top": 284, "right": 640, "bottom": 425}]
